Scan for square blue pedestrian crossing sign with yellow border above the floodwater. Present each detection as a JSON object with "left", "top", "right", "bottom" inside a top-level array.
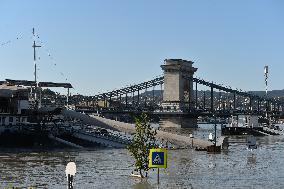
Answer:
[{"left": 149, "top": 148, "right": 167, "bottom": 168}]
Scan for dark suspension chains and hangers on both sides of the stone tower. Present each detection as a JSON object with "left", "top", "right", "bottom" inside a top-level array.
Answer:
[{"left": 80, "top": 76, "right": 283, "bottom": 116}]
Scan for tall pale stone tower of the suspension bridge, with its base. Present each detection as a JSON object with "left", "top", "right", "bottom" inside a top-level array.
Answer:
[{"left": 161, "top": 59, "right": 197, "bottom": 127}]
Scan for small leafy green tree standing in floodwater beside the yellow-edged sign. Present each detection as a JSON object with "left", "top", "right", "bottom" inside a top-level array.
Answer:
[{"left": 127, "top": 113, "right": 158, "bottom": 178}]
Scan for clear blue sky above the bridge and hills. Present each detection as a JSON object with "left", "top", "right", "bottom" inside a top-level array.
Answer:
[{"left": 0, "top": 0, "right": 284, "bottom": 95}]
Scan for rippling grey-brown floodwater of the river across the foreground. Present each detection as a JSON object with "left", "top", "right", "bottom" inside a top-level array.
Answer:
[{"left": 0, "top": 125, "right": 284, "bottom": 189}]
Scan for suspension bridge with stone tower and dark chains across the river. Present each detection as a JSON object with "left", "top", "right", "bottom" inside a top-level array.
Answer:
[{"left": 77, "top": 59, "right": 283, "bottom": 127}]
